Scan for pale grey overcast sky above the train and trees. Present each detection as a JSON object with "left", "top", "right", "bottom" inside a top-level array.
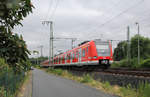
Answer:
[{"left": 14, "top": 0, "right": 150, "bottom": 57}]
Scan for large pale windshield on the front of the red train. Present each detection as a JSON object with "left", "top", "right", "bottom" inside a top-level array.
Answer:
[{"left": 95, "top": 42, "right": 110, "bottom": 56}]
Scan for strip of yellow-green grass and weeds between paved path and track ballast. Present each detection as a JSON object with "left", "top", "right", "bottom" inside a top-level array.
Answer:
[{"left": 46, "top": 68, "right": 150, "bottom": 97}]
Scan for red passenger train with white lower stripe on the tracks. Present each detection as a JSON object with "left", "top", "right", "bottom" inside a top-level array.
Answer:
[{"left": 41, "top": 40, "right": 113, "bottom": 67}]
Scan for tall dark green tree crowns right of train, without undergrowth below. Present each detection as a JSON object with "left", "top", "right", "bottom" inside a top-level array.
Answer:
[{"left": 114, "top": 35, "right": 150, "bottom": 61}]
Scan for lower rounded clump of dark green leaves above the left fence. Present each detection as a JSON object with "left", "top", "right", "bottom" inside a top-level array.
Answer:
[{"left": 0, "top": 33, "right": 30, "bottom": 71}]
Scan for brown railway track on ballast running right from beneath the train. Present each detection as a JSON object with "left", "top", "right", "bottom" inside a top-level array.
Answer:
[{"left": 62, "top": 67, "right": 150, "bottom": 78}]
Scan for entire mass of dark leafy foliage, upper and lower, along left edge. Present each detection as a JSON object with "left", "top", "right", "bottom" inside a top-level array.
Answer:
[{"left": 0, "top": 0, "right": 33, "bottom": 71}]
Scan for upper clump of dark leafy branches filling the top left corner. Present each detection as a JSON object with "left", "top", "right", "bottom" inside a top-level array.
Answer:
[{"left": 0, "top": 0, "right": 33, "bottom": 32}]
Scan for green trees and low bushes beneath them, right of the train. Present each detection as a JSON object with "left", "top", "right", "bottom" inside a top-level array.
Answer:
[{"left": 114, "top": 35, "right": 150, "bottom": 67}]
